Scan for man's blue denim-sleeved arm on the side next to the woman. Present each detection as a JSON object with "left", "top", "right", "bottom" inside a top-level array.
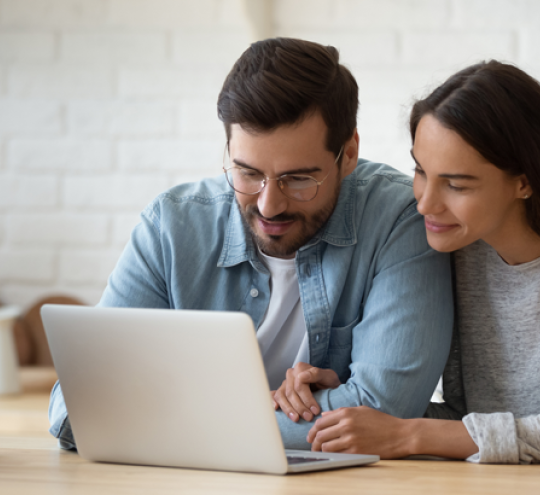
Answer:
[{"left": 276, "top": 206, "right": 453, "bottom": 449}]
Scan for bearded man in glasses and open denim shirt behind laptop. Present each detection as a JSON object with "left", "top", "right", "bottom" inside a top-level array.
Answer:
[{"left": 51, "top": 38, "right": 453, "bottom": 448}]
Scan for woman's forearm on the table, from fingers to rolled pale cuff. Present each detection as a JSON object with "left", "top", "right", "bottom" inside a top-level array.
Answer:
[{"left": 307, "top": 406, "right": 540, "bottom": 464}]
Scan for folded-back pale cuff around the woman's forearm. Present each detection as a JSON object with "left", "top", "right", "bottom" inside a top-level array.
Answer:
[{"left": 463, "top": 413, "right": 519, "bottom": 464}]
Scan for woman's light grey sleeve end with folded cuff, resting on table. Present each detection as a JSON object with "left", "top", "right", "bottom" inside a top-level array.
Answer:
[{"left": 463, "top": 412, "right": 540, "bottom": 464}]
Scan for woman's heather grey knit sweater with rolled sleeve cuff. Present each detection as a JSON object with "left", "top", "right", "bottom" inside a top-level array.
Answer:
[{"left": 426, "top": 241, "right": 540, "bottom": 464}]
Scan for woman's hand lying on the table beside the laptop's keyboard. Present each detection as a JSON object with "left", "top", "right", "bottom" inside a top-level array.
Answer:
[{"left": 307, "top": 406, "right": 411, "bottom": 459}]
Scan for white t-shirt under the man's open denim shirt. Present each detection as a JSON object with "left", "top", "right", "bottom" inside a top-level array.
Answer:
[{"left": 257, "top": 251, "right": 309, "bottom": 390}]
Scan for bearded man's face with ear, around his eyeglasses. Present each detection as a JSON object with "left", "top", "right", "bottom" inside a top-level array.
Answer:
[{"left": 226, "top": 113, "right": 358, "bottom": 258}]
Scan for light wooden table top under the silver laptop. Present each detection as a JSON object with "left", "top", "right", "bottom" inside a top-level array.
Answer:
[{"left": 0, "top": 392, "right": 540, "bottom": 495}]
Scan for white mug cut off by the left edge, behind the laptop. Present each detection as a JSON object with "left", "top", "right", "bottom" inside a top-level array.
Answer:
[{"left": 0, "top": 306, "right": 21, "bottom": 394}]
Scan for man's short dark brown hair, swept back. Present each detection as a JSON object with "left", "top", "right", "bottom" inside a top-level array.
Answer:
[{"left": 218, "top": 38, "right": 358, "bottom": 160}]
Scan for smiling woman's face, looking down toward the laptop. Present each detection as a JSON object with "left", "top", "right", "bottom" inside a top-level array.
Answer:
[{"left": 411, "top": 115, "right": 531, "bottom": 252}]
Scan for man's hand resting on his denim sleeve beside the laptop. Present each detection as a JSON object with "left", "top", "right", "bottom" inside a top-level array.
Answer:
[{"left": 271, "top": 363, "right": 341, "bottom": 421}]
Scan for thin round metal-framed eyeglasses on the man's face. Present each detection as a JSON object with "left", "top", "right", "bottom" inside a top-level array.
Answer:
[{"left": 223, "top": 146, "right": 343, "bottom": 201}]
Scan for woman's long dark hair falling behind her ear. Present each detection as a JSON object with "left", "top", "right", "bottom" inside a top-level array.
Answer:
[{"left": 409, "top": 60, "right": 540, "bottom": 234}]
